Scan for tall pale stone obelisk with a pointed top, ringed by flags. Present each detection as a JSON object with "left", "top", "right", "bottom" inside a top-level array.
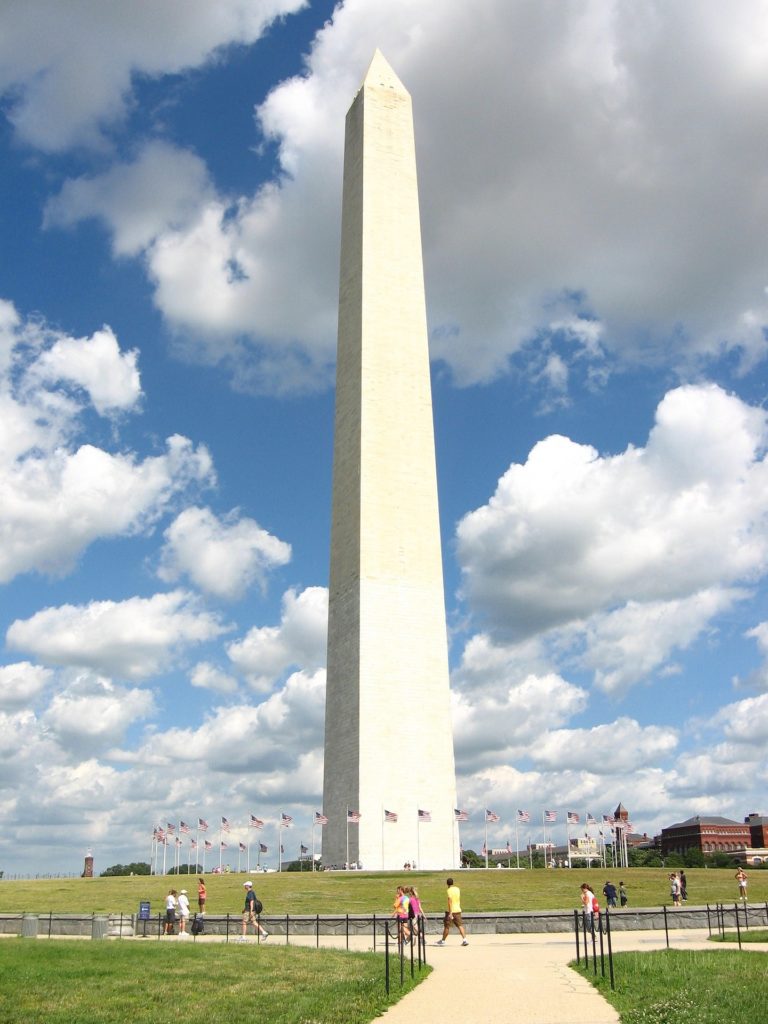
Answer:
[{"left": 323, "top": 50, "right": 458, "bottom": 869}]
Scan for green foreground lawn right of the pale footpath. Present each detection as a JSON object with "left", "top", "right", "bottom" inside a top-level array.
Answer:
[{"left": 588, "top": 949, "right": 768, "bottom": 1024}]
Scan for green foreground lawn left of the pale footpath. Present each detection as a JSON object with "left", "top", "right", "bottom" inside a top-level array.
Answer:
[{"left": 0, "top": 939, "right": 429, "bottom": 1024}]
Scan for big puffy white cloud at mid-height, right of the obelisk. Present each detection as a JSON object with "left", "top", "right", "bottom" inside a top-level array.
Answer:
[{"left": 457, "top": 385, "right": 768, "bottom": 671}]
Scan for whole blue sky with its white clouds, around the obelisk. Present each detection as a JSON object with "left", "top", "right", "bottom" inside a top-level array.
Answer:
[{"left": 0, "top": 0, "right": 768, "bottom": 873}]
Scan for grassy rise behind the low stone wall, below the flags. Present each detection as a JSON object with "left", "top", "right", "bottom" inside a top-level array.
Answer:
[{"left": 0, "top": 867, "right": 768, "bottom": 914}]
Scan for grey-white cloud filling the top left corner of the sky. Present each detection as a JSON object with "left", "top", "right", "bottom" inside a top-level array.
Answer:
[{"left": 0, "top": 0, "right": 304, "bottom": 151}]
